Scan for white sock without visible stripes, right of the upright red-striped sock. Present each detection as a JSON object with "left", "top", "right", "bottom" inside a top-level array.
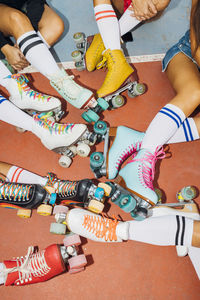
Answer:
[{"left": 119, "top": 4, "right": 141, "bottom": 36}]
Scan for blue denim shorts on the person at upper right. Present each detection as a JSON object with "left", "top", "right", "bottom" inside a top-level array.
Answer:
[{"left": 162, "top": 30, "right": 197, "bottom": 72}]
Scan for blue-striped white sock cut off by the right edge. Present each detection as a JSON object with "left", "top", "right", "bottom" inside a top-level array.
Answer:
[{"left": 168, "top": 118, "right": 199, "bottom": 144}]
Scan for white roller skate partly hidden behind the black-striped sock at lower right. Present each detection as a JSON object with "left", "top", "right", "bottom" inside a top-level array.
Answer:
[{"left": 148, "top": 186, "right": 200, "bottom": 257}]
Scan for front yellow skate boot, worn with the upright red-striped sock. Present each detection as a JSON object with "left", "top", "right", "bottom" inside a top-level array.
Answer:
[{"left": 97, "top": 49, "right": 134, "bottom": 97}]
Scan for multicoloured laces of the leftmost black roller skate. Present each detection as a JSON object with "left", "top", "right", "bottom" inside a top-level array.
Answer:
[{"left": 0, "top": 180, "right": 31, "bottom": 201}]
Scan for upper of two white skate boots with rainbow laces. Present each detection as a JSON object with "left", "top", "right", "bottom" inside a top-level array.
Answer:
[{"left": 5, "top": 74, "right": 64, "bottom": 121}]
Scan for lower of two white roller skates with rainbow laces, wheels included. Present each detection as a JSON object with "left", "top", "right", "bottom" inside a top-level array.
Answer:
[{"left": 32, "top": 114, "right": 96, "bottom": 168}]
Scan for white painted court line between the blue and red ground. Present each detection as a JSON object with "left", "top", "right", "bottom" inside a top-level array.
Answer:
[{"left": 20, "top": 54, "right": 165, "bottom": 73}]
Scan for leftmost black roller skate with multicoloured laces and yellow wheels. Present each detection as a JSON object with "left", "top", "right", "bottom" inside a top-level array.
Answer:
[{"left": 0, "top": 179, "right": 56, "bottom": 218}]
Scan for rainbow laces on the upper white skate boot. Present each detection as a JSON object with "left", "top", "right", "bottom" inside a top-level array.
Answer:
[{"left": 8, "top": 74, "right": 51, "bottom": 102}]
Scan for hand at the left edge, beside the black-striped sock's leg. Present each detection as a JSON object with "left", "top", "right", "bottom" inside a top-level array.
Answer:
[{"left": 1, "top": 44, "right": 29, "bottom": 71}]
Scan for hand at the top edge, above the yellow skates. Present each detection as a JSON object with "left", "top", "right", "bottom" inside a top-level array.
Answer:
[{"left": 129, "top": 0, "right": 158, "bottom": 21}]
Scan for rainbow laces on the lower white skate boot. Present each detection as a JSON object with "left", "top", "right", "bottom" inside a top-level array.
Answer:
[{"left": 33, "top": 112, "right": 74, "bottom": 134}]
